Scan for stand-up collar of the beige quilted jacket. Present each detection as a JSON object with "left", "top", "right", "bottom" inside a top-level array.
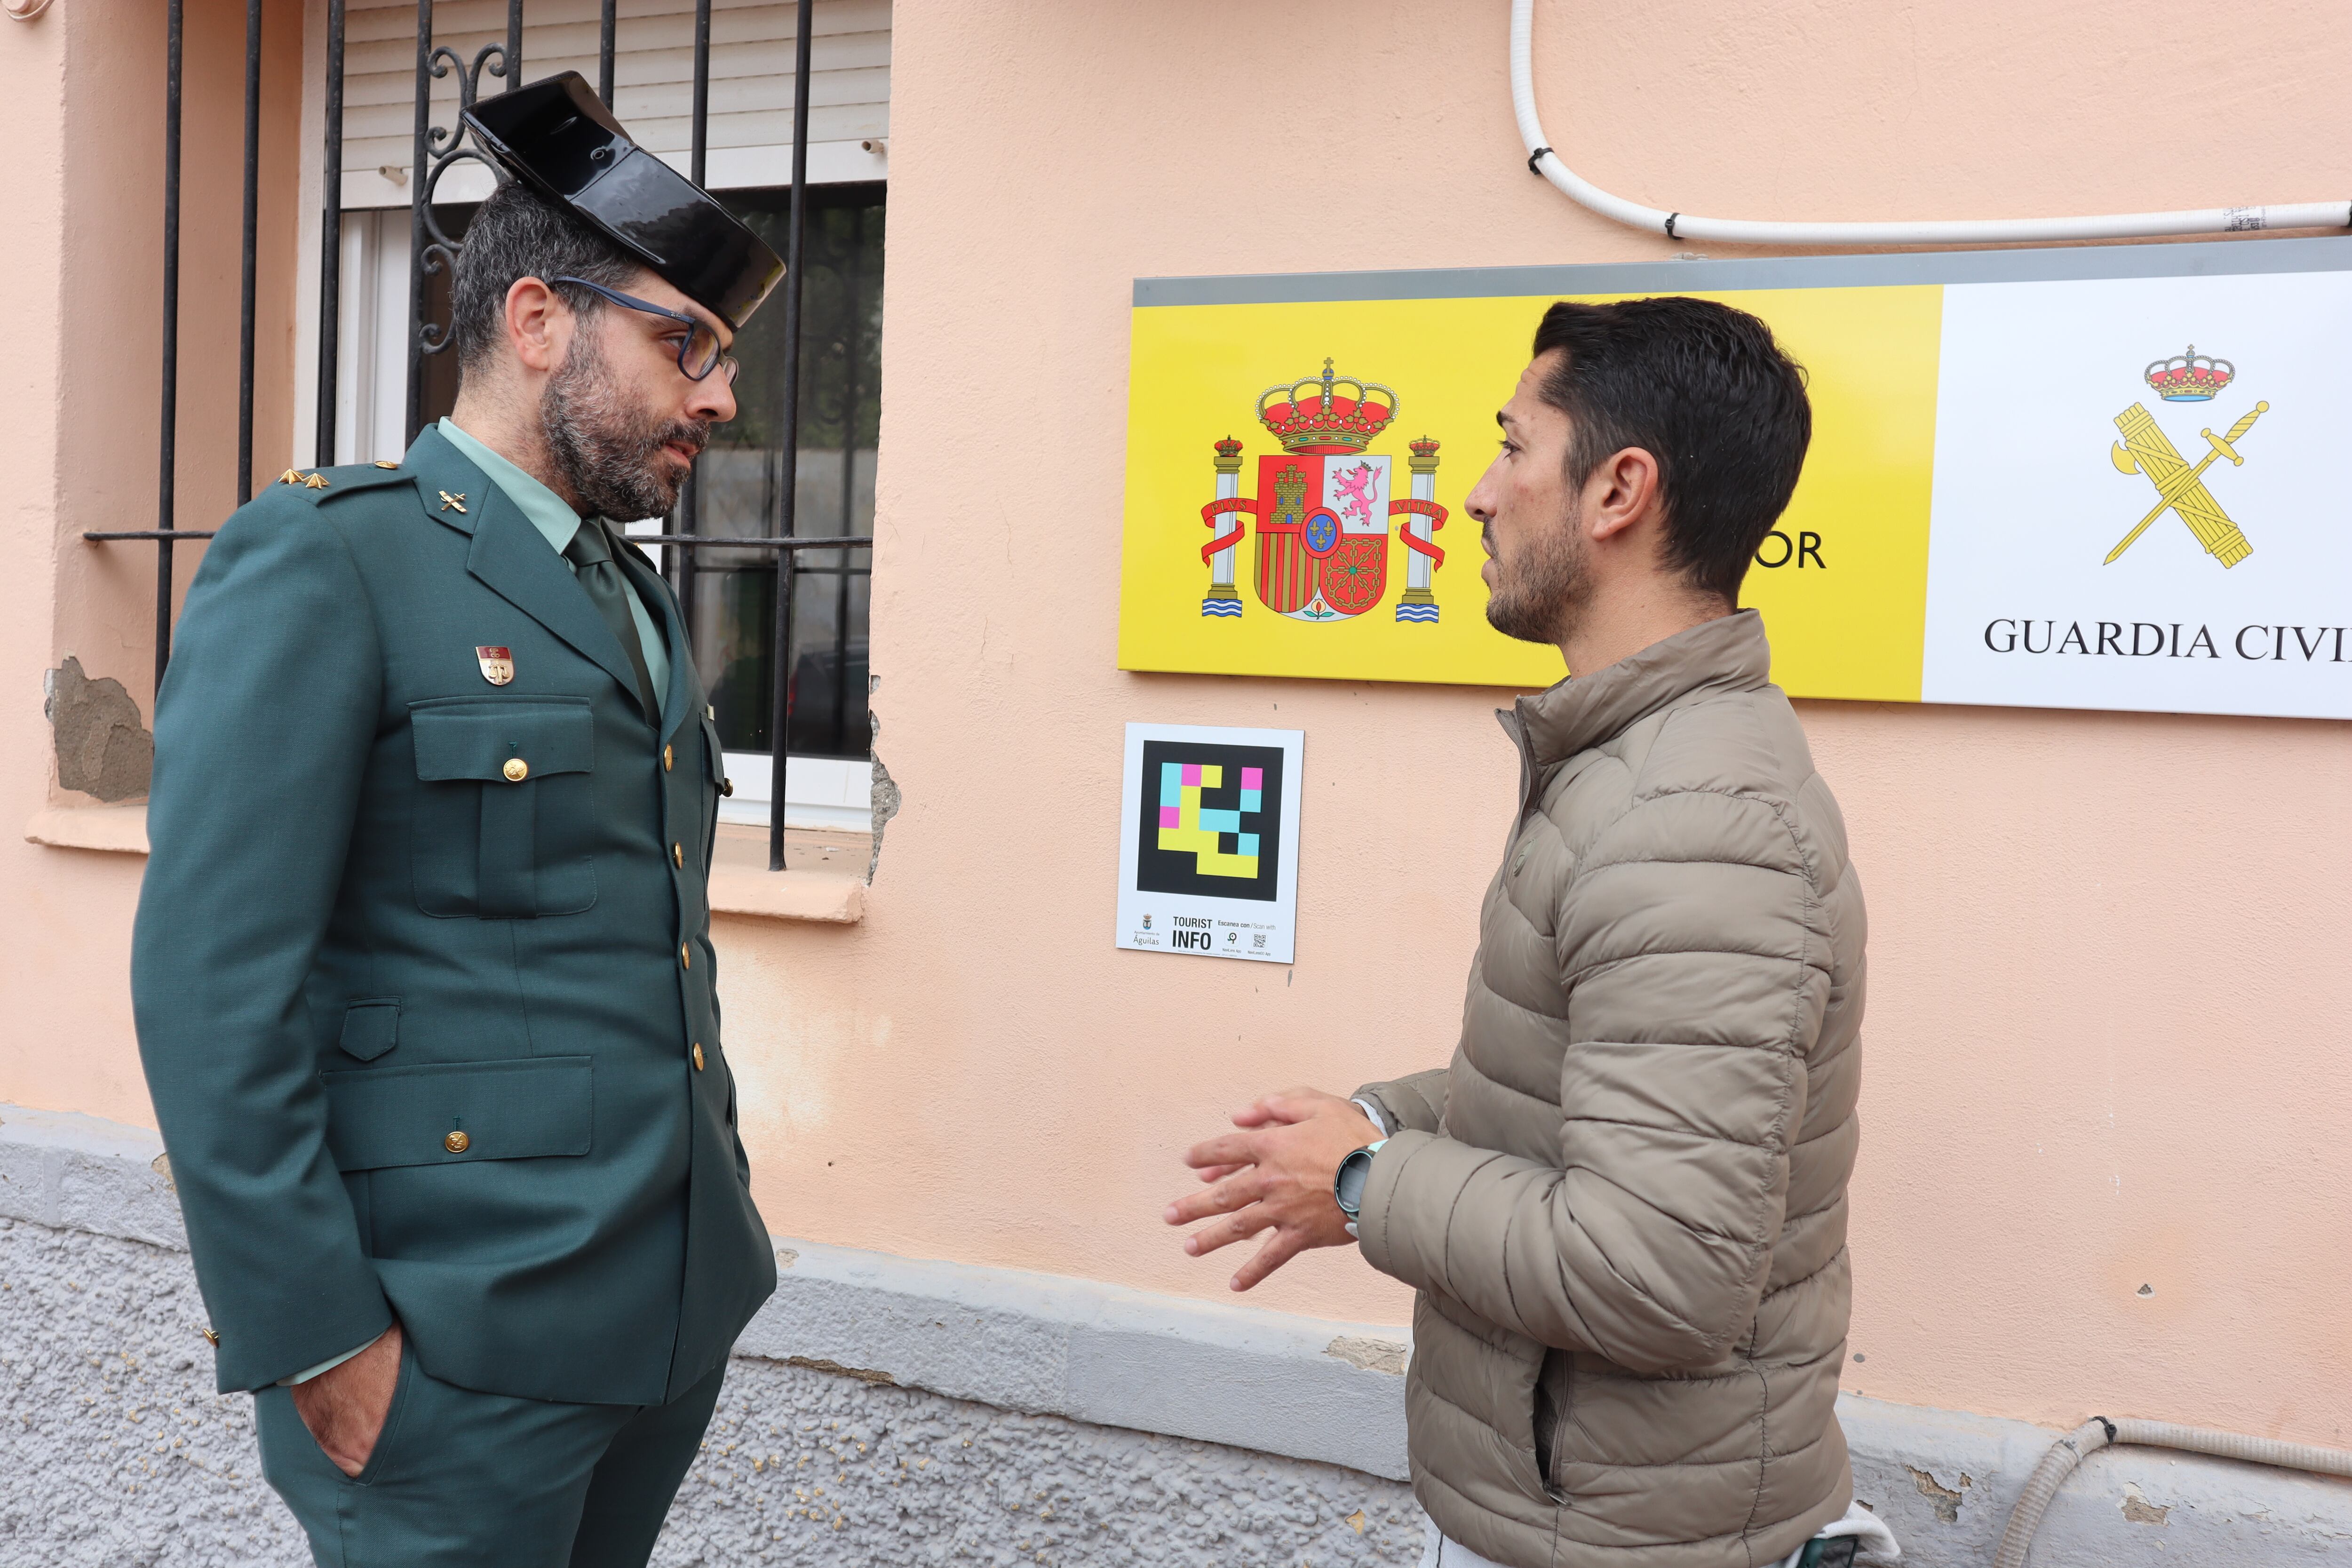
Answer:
[{"left": 1498, "top": 609, "right": 1771, "bottom": 769}]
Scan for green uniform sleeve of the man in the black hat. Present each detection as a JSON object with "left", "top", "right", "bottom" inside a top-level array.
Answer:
[{"left": 132, "top": 491, "right": 393, "bottom": 1392}]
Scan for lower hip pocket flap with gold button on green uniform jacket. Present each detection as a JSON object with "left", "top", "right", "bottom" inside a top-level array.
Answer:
[{"left": 320, "top": 1056, "right": 595, "bottom": 1171}]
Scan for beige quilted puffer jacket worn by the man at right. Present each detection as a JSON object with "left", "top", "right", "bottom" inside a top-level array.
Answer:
[{"left": 1359, "top": 611, "right": 1863, "bottom": 1568}]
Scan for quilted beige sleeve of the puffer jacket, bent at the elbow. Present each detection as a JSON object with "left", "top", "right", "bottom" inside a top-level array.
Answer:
[{"left": 1359, "top": 790, "right": 1830, "bottom": 1373}]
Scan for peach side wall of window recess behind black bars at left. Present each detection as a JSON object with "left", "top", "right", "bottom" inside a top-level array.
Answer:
[{"left": 56, "top": 0, "right": 301, "bottom": 724}]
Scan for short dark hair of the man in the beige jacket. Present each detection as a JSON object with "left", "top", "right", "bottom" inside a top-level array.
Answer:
[{"left": 1536, "top": 296, "right": 1813, "bottom": 604}]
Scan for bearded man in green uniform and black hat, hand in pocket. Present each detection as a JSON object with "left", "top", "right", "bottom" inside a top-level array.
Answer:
[{"left": 132, "top": 75, "right": 783, "bottom": 1568}]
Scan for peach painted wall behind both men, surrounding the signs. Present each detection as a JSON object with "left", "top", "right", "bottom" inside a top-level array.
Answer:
[{"left": 0, "top": 0, "right": 2352, "bottom": 1443}]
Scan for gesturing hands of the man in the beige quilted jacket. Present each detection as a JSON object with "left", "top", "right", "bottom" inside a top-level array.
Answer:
[{"left": 1162, "top": 1089, "right": 1381, "bottom": 1290}]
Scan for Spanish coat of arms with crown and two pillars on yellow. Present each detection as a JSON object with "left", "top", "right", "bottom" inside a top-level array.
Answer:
[{"left": 1200, "top": 360, "right": 1446, "bottom": 625}]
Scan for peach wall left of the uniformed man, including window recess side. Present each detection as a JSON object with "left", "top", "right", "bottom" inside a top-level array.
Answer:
[{"left": 0, "top": 0, "right": 301, "bottom": 1122}]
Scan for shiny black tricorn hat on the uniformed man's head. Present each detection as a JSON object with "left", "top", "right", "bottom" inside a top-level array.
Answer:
[{"left": 466, "top": 71, "right": 783, "bottom": 329}]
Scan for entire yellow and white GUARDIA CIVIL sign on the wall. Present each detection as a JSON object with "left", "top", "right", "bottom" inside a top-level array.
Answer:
[{"left": 1120, "top": 238, "right": 2352, "bottom": 719}]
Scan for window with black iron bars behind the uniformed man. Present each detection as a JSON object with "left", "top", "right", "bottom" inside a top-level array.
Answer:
[{"left": 85, "top": 0, "right": 889, "bottom": 870}]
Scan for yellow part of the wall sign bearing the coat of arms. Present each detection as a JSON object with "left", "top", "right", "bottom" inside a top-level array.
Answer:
[{"left": 1120, "top": 285, "right": 1938, "bottom": 700}]
